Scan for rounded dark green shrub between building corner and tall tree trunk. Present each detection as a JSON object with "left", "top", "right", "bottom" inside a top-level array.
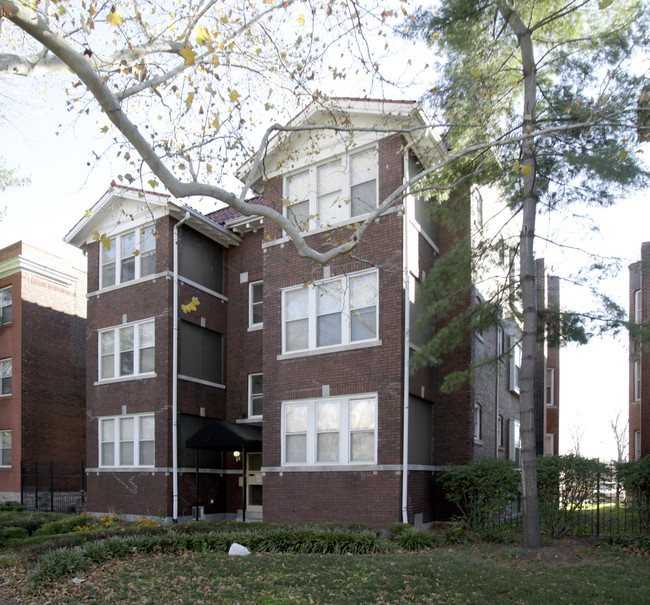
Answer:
[{"left": 440, "top": 459, "right": 520, "bottom": 529}]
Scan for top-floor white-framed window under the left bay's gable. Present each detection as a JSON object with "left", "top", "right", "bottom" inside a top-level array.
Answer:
[{"left": 100, "top": 225, "right": 156, "bottom": 288}]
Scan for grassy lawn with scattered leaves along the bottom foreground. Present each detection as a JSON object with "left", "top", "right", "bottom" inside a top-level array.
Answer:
[{"left": 5, "top": 541, "right": 650, "bottom": 605}]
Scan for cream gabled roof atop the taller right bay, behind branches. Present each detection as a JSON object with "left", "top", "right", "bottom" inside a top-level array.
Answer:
[{"left": 237, "top": 98, "right": 446, "bottom": 192}]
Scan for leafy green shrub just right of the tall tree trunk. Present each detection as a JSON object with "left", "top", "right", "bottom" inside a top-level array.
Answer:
[{"left": 537, "top": 454, "right": 610, "bottom": 537}]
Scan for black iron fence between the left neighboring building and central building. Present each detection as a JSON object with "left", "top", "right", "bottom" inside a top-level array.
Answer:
[{"left": 20, "top": 462, "right": 86, "bottom": 513}]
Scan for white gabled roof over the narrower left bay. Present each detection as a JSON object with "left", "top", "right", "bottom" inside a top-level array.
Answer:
[{"left": 63, "top": 182, "right": 241, "bottom": 248}]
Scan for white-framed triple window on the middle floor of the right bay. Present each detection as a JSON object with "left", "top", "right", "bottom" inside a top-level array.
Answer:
[{"left": 282, "top": 270, "right": 379, "bottom": 353}]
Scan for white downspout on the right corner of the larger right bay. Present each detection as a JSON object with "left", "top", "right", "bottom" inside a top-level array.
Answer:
[{"left": 402, "top": 145, "right": 411, "bottom": 523}]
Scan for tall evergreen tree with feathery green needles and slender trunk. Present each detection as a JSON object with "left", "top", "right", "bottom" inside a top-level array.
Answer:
[{"left": 405, "top": 0, "right": 650, "bottom": 548}]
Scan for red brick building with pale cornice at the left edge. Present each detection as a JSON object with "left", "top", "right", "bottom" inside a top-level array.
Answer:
[{"left": 0, "top": 242, "right": 86, "bottom": 500}]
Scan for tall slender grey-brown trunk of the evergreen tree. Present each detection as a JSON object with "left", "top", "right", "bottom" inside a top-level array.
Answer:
[{"left": 498, "top": 2, "right": 542, "bottom": 549}]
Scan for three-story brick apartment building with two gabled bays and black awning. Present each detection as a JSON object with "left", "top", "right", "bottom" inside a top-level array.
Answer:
[{"left": 66, "top": 100, "right": 558, "bottom": 525}]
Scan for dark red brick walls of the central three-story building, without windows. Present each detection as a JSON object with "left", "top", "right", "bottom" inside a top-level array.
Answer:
[{"left": 71, "top": 101, "right": 552, "bottom": 526}]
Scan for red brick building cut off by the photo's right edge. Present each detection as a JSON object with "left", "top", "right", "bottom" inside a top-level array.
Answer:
[{"left": 628, "top": 242, "right": 650, "bottom": 460}]
